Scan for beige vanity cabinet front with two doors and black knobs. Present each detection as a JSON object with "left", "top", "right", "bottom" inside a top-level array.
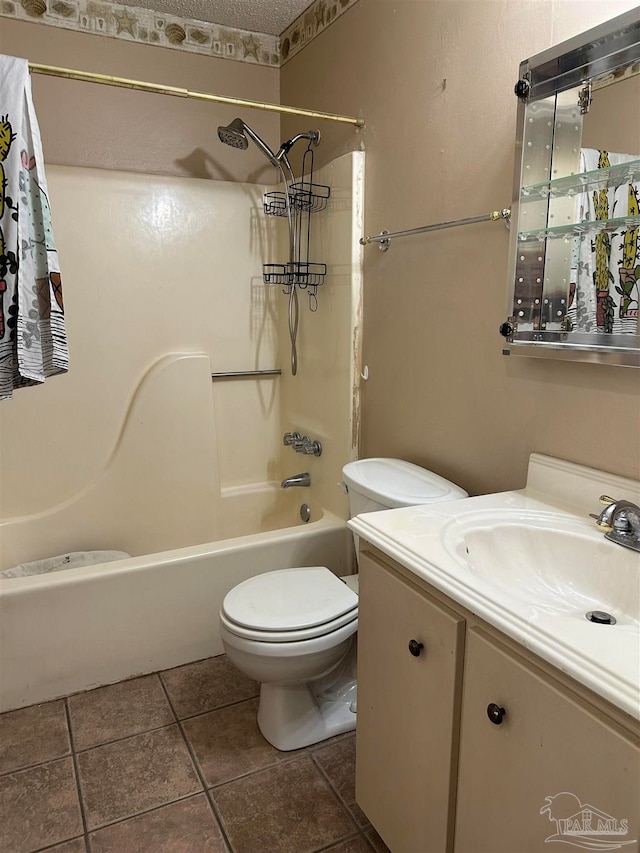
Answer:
[{"left": 356, "top": 551, "right": 640, "bottom": 853}]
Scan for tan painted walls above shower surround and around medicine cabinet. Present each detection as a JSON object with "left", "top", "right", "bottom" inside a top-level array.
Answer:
[{"left": 0, "top": 5, "right": 640, "bottom": 500}]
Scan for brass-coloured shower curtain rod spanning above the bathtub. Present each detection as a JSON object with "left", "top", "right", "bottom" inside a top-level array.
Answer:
[{"left": 29, "top": 62, "right": 364, "bottom": 127}]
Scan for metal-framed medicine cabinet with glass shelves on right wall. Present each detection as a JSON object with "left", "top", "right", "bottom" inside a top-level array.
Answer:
[{"left": 500, "top": 7, "right": 640, "bottom": 367}]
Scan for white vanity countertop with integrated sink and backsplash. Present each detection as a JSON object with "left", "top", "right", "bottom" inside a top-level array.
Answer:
[{"left": 349, "top": 453, "right": 640, "bottom": 719}]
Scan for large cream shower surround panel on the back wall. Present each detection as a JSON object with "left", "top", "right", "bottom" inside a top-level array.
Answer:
[{"left": 0, "top": 167, "right": 280, "bottom": 560}]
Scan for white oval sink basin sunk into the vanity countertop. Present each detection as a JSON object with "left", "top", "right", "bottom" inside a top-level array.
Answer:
[{"left": 442, "top": 511, "right": 640, "bottom": 624}]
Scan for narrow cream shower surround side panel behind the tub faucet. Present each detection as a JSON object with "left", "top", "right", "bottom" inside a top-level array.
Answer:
[{"left": 278, "top": 150, "right": 364, "bottom": 518}]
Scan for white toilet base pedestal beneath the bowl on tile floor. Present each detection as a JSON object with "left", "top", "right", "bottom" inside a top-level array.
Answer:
[{"left": 258, "top": 638, "right": 357, "bottom": 752}]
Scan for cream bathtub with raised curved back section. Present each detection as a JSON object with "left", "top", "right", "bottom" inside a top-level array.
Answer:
[{"left": 0, "top": 354, "right": 353, "bottom": 711}]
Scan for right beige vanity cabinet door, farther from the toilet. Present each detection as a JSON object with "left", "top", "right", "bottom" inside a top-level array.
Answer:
[{"left": 455, "top": 626, "right": 640, "bottom": 853}]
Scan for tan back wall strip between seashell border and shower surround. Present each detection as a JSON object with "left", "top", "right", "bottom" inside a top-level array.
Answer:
[{"left": 0, "top": 18, "right": 280, "bottom": 183}]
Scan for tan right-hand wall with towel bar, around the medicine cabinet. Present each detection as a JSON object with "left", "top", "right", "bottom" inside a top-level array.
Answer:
[{"left": 281, "top": 0, "right": 640, "bottom": 493}]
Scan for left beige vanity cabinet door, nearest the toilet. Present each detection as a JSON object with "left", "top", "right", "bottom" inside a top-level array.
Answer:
[{"left": 356, "top": 554, "right": 464, "bottom": 853}]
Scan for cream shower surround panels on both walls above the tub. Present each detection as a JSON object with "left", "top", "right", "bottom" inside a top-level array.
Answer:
[{"left": 0, "top": 155, "right": 361, "bottom": 568}]
